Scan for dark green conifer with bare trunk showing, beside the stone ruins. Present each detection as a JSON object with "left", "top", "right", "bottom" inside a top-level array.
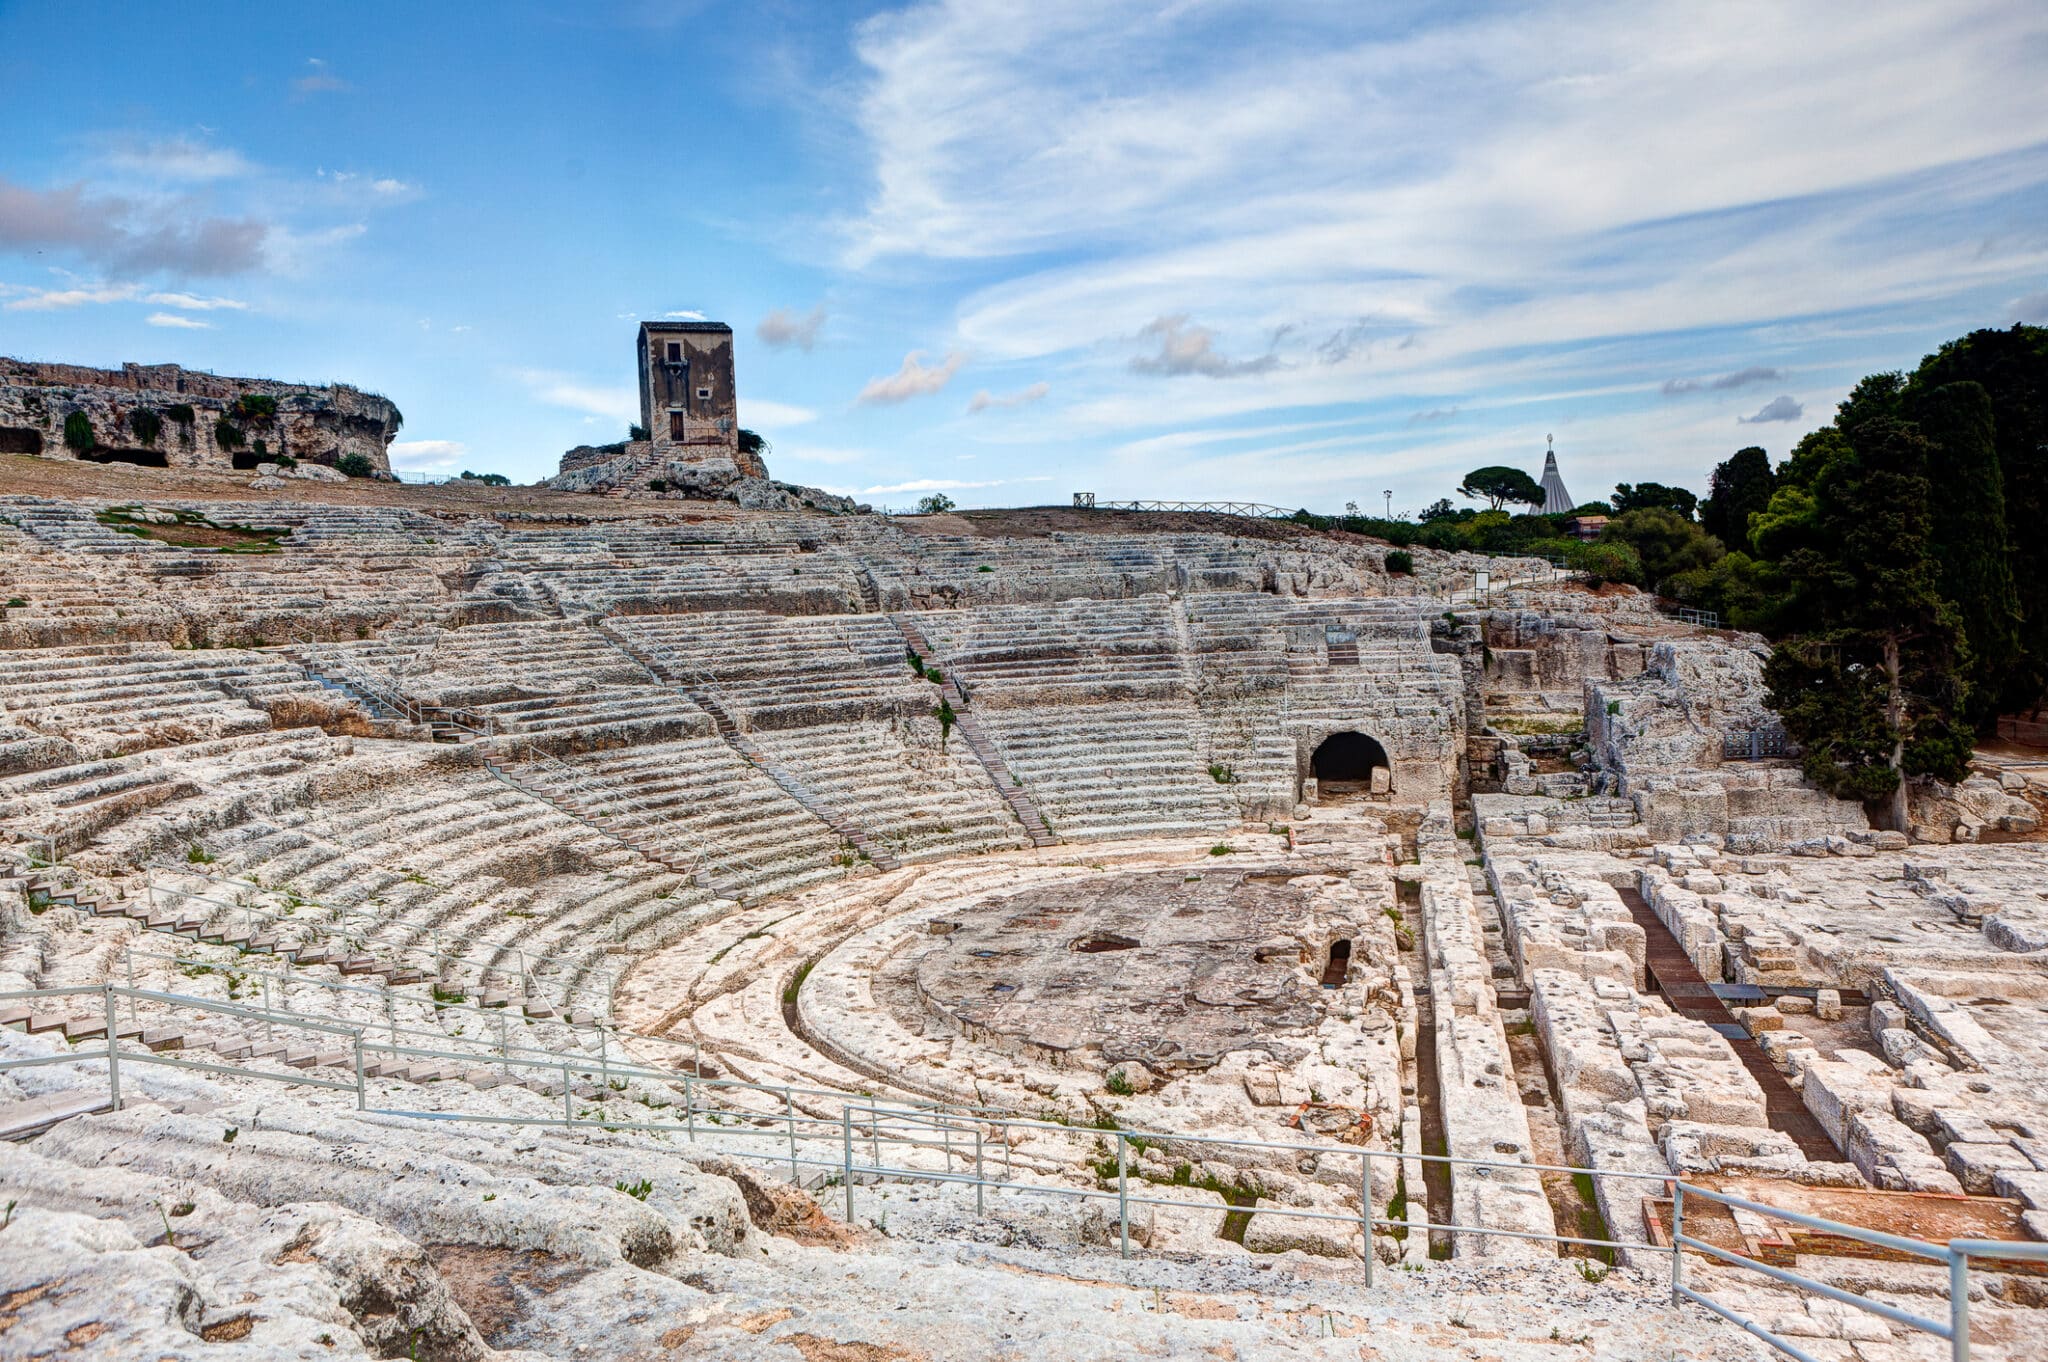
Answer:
[{"left": 1763, "top": 416, "right": 1972, "bottom": 832}]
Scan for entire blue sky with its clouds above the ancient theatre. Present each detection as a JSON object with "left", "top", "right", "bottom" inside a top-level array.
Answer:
[{"left": 0, "top": 0, "right": 2048, "bottom": 512}]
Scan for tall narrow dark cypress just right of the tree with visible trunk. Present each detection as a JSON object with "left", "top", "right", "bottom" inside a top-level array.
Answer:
[{"left": 1909, "top": 383, "right": 2019, "bottom": 729}]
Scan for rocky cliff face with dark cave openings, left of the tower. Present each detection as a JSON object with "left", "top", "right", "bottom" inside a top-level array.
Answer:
[{"left": 0, "top": 358, "right": 403, "bottom": 473}]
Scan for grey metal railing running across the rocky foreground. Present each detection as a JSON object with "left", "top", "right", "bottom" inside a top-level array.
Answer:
[{"left": 0, "top": 983, "right": 2048, "bottom": 1362}]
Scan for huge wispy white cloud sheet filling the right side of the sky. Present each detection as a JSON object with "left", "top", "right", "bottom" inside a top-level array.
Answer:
[{"left": 844, "top": 0, "right": 2048, "bottom": 492}]
